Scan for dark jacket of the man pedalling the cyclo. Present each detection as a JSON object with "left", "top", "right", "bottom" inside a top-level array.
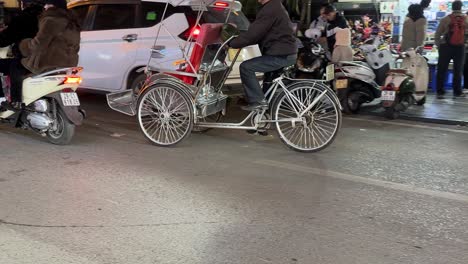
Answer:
[{"left": 229, "top": 0, "right": 297, "bottom": 56}]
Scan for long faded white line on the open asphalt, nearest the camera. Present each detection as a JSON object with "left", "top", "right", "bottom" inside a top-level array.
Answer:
[{"left": 254, "top": 160, "right": 468, "bottom": 203}]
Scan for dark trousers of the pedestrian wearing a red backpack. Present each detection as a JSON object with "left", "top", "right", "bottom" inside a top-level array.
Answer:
[{"left": 437, "top": 44, "right": 465, "bottom": 95}]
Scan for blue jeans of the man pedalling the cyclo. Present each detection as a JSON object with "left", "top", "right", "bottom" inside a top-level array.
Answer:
[{"left": 239, "top": 54, "right": 297, "bottom": 103}]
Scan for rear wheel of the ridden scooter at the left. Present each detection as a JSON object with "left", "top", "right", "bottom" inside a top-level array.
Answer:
[{"left": 47, "top": 108, "right": 75, "bottom": 145}]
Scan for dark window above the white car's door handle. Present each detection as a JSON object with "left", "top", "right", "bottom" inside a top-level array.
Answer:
[{"left": 93, "top": 5, "right": 136, "bottom": 30}]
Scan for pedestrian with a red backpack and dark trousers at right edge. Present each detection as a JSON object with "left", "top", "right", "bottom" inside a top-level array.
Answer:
[{"left": 434, "top": 0, "right": 468, "bottom": 99}]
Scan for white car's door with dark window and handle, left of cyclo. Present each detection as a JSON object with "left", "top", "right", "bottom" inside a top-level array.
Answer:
[{"left": 79, "top": 4, "right": 139, "bottom": 91}]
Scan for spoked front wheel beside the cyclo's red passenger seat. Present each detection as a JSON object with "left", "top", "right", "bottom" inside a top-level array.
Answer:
[{"left": 137, "top": 85, "right": 193, "bottom": 147}]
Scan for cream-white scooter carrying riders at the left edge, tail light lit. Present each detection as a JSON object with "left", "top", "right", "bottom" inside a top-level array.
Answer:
[{"left": 0, "top": 68, "right": 86, "bottom": 145}]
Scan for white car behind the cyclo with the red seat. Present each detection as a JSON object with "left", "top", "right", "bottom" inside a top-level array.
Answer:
[{"left": 68, "top": 0, "right": 261, "bottom": 92}]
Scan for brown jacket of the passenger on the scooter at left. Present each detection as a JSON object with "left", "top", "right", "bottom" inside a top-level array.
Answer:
[{"left": 20, "top": 8, "right": 80, "bottom": 74}]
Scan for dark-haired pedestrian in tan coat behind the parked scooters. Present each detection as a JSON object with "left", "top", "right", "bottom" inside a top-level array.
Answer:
[{"left": 400, "top": 4, "right": 427, "bottom": 51}]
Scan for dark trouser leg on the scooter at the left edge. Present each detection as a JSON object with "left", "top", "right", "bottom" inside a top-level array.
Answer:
[{"left": 0, "top": 59, "right": 30, "bottom": 102}]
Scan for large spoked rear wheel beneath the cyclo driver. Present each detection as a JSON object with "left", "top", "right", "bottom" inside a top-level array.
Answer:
[{"left": 273, "top": 84, "right": 341, "bottom": 152}]
